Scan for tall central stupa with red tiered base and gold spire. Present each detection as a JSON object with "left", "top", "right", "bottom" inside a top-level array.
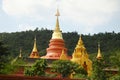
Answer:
[{"left": 41, "top": 9, "right": 67, "bottom": 59}]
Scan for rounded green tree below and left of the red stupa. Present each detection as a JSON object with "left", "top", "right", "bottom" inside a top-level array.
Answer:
[{"left": 24, "top": 59, "right": 47, "bottom": 76}]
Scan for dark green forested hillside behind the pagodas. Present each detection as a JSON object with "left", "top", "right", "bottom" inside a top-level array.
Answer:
[{"left": 0, "top": 28, "right": 120, "bottom": 57}]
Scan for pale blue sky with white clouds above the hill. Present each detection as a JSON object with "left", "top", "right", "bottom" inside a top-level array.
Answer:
[{"left": 0, "top": 0, "right": 120, "bottom": 34}]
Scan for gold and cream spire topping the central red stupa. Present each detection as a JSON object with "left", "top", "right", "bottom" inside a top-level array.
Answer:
[{"left": 52, "top": 9, "right": 63, "bottom": 39}]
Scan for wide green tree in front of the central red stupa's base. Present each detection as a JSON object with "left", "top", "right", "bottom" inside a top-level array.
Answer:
[{"left": 52, "top": 60, "right": 85, "bottom": 77}]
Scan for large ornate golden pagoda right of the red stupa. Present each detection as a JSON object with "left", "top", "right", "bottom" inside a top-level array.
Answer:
[{"left": 71, "top": 36, "right": 92, "bottom": 76}]
